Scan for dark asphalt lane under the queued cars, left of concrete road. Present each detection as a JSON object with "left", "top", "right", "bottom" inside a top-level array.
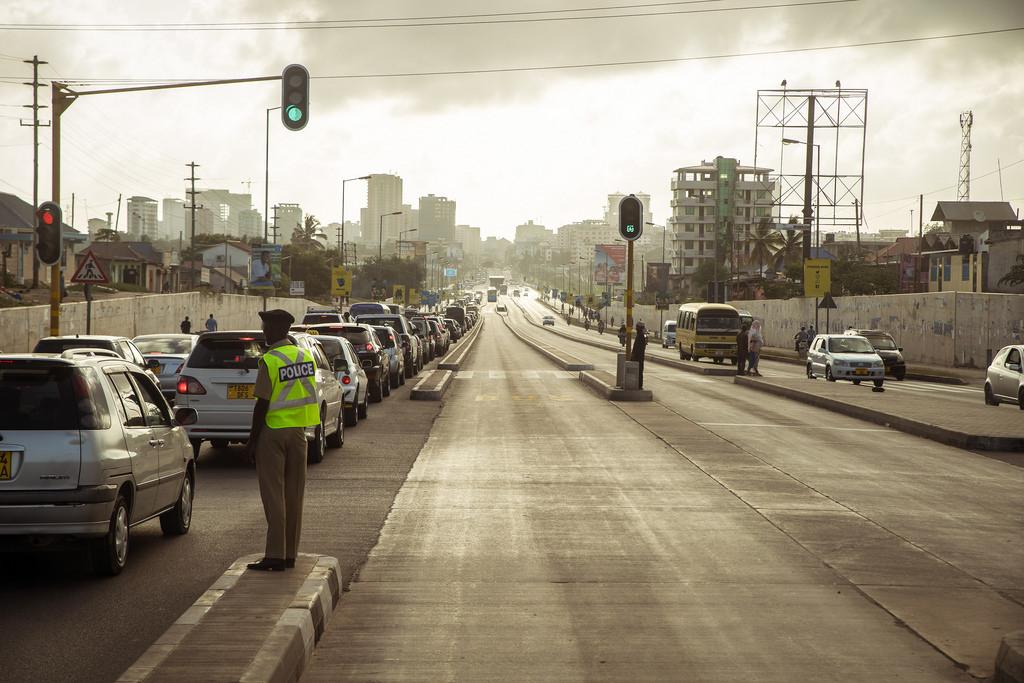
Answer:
[{"left": 0, "top": 352, "right": 439, "bottom": 683}]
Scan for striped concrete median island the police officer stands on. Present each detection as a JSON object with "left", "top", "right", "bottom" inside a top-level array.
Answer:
[{"left": 118, "top": 553, "right": 341, "bottom": 683}]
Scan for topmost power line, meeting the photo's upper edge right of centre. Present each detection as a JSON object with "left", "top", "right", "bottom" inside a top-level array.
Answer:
[{"left": 0, "top": 0, "right": 860, "bottom": 33}]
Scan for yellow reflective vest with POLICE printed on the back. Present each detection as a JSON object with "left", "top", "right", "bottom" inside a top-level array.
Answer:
[{"left": 263, "top": 344, "right": 319, "bottom": 429}]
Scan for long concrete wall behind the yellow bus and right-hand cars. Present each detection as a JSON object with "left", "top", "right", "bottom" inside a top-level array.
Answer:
[{"left": 608, "top": 292, "right": 1024, "bottom": 368}]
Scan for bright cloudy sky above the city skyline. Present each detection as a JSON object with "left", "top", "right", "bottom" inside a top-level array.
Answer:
[{"left": 0, "top": 0, "right": 1024, "bottom": 238}]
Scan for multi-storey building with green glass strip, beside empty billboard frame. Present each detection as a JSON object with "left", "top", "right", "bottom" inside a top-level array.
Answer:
[{"left": 668, "top": 157, "right": 775, "bottom": 276}]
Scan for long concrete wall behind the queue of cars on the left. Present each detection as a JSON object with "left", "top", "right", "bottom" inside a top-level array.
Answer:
[{"left": 0, "top": 292, "right": 312, "bottom": 353}]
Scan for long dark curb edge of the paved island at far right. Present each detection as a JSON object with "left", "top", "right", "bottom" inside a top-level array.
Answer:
[{"left": 732, "top": 375, "right": 1024, "bottom": 451}]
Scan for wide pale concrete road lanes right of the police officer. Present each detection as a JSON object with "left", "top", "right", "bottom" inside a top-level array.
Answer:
[{"left": 304, "top": 308, "right": 1024, "bottom": 681}]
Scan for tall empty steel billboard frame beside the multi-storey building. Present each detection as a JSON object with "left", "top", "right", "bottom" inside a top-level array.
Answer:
[{"left": 754, "top": 87, "right": 867, "bottom": 246}]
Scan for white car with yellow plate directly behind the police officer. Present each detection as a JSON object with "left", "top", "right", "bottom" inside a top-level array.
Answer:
[{"left": 174, "top": 331, "right": 345, "bottom": 463}]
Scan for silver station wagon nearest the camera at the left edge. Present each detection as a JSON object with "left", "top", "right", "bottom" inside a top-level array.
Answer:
[{"left": 0, "top": 348, "right": 196, "bottom": 575}]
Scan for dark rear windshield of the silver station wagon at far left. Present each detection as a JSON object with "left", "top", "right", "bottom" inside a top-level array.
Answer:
[{"left": 0, "top": 362, "right": 111, "bottom": 430}]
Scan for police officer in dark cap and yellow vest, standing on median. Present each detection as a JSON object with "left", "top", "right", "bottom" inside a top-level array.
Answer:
[{"left": 248, "top": 309, "right": 319, "bottom": 571}]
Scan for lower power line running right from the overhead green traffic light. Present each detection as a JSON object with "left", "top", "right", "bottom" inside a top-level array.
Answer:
[{"left": 14, "top": 27, "right": 1024, "bottom": 86}]
